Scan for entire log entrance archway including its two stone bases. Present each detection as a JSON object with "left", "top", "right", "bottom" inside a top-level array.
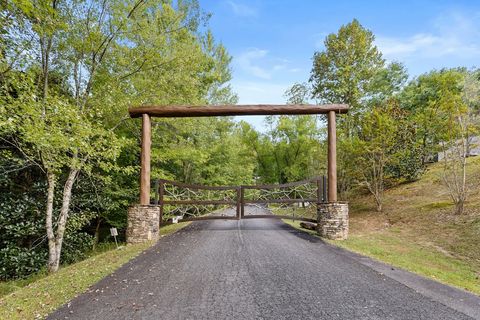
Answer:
[{"left": 127, "top": 104, "right": 348, "bottom": 243}]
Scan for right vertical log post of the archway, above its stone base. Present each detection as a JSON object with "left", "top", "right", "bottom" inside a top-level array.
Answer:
[{"left": 328, "top": 111, "right": 337, "bottom": 202}]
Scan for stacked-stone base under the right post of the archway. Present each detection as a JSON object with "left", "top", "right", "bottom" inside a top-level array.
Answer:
[{"left": 317, "top": 202, "right": 348, "bottom": 240}]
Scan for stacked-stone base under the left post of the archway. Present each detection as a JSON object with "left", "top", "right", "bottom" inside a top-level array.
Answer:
[{"left": 127, "top": 204, "right": 160, "bottom": 244}]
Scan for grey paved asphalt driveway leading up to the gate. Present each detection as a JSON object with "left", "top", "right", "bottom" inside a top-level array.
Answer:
[{"left": 49, "top": 206, "right": 480, "bottom": 320}]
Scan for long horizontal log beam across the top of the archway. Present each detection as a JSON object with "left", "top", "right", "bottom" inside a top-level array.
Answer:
[{"left": 128, "top": 104, "right": 348, "bottom": 118}]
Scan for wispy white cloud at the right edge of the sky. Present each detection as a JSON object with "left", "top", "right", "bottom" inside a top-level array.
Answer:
[{"left": 376, "top": 12, "right": 480, "bottom": 60}]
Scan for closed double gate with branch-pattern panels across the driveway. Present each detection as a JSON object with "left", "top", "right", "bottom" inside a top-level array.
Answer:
[{"left": 153, "top": 176, "right": 328, "bottom": 224}]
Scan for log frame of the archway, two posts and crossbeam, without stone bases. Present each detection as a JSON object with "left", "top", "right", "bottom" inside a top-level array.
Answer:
[{"left": 128, "top": 104, "right": 348, "bottom": 205}]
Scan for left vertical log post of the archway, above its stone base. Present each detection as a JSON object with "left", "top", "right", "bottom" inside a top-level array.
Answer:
[{"left": 140, "top": 114, "right": 152, "bottom": 205}]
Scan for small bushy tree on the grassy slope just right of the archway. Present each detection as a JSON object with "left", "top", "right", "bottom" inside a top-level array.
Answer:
[{"left": 347, "top": 99, "right": 424, "bottom": 211}]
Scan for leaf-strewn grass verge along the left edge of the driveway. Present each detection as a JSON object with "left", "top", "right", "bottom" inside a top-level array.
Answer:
[{"left": 0, "top": 223, "right": 189, "bottom": 320}]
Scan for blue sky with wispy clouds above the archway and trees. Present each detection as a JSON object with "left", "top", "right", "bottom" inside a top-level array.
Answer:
[{"left": 200, "top": 0, "right": 480, "bottom": 128}]
